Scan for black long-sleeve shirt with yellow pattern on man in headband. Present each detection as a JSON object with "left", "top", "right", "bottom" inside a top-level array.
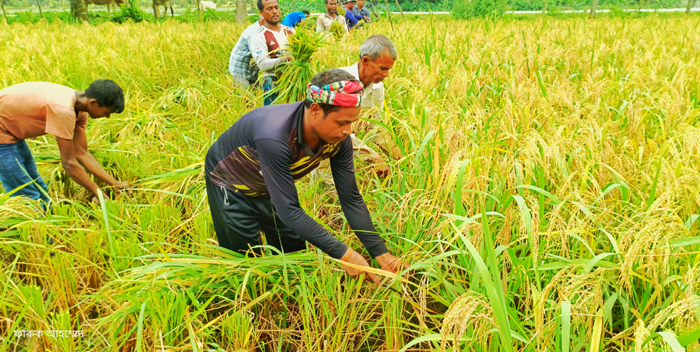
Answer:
[{"left": 205, "top": 103, "right": 388, "bottom": 258}]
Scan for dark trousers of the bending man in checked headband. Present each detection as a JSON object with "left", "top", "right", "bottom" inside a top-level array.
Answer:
[{"left": 205, "top": 173, "right": 306, "bottom": 255}]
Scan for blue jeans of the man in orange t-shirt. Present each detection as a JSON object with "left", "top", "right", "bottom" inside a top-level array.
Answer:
[{"left": 0, "top": 140, "right": 49, "bottom": 207}]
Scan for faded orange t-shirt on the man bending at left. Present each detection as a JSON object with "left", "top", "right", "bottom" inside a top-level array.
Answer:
[{"left": 0, "top": 82, "right": 88, "bottom": 144}]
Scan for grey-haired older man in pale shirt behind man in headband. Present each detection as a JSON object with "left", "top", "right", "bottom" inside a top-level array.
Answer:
[{"left": 312, "top": 34, "right": 398, "bottom": 185}]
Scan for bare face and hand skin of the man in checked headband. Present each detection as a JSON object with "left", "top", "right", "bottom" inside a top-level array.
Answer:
[{"left": 303, "top": 103, "right": 405, "bottom": 283}]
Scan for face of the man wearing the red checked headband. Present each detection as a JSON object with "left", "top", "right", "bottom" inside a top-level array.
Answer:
[{"left": 311, "top": 104, "right": 362, "bottom": 144}]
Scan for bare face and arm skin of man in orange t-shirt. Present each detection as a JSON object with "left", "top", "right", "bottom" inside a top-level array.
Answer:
[{"left": 56, "top": 92, "right": 129, "bottom": 201}]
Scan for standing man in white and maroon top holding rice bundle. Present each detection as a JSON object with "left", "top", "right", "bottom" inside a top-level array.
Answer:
[{"left": 251, "top": 0, "right": 296, "bottom": 105}]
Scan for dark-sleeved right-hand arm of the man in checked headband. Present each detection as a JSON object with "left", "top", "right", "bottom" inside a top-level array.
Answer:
[{"left": 330, "top": 137, "right": 389, "bottom": 258}]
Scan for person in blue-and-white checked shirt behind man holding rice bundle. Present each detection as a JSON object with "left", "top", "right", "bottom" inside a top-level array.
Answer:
[{"left": 228, "top": 15, "right": 264, "bottom": 88}]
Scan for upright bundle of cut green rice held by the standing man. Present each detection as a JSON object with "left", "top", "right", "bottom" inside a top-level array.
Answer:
[{"left": 275, "top": 28, "right": 325, "bottom": 104}]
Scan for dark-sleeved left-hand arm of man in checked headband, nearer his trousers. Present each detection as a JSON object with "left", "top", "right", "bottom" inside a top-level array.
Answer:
[{"left": 255, "top": 139, "right": 348, "bottom": 259}]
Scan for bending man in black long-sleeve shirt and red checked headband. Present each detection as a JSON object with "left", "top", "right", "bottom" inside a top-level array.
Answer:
[{"left": 205, "top": 69, "right": 401, "bottom": 283}]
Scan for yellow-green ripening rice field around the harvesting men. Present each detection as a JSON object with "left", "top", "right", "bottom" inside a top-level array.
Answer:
[{"left": 0, "top": 15, "right": 700, "bottom": 352}]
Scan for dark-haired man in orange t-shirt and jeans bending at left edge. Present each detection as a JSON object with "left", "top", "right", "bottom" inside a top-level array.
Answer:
[{"left": 0, "top": 79, "right": 128, "bottom": 207}]
